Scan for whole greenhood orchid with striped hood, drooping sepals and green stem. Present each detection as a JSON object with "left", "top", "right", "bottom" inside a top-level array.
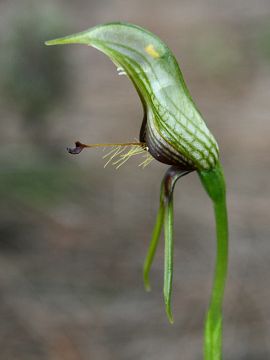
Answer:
[{"left": 46, "top": 23, "right": 228, "bottom": 360}]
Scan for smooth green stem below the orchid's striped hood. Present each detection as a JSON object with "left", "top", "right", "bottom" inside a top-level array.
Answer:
[{"left": 199, "top": 164, "right": 228, "bottom": 360}]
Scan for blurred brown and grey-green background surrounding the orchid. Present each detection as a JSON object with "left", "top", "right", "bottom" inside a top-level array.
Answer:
[{"left": 0, "top": 0, "right": 270, "bottom": 360}]
